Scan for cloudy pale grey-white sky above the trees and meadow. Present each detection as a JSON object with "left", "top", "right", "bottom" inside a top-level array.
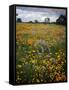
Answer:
[{"left": 16, "top": 6, "right": 66, "bottom": 22}]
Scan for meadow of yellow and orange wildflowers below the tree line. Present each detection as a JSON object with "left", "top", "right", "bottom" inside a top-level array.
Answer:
[{"left": 16, "top": 23, "right": 67, "bottom": 84}]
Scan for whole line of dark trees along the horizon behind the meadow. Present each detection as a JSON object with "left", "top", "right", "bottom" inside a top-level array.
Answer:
[{"left": 16, "top": 14, "right": 67, "bottom": 25}]
